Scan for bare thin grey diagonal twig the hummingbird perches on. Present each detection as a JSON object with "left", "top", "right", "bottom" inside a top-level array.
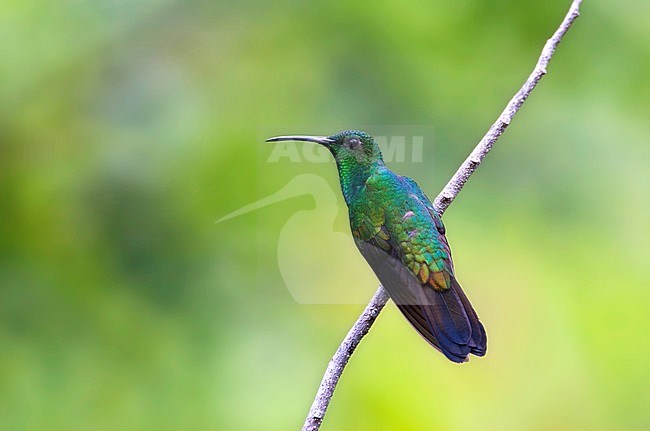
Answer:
[{"left": 302, "top": 0, "right": 582, "bottom": 431}]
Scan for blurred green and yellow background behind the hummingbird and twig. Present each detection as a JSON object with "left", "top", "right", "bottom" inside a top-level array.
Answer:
[{"left": 0, "top": 0, "right": 650, "bottom": 430}]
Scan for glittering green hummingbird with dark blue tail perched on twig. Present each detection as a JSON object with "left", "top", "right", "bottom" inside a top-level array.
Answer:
[{"left": 266, "top": 130, "right": 487, "bottom": 363}]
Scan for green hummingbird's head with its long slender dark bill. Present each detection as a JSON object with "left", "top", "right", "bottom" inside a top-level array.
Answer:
[{"left": 266, "top": 130, "right": 383, "bottom": 166}]
